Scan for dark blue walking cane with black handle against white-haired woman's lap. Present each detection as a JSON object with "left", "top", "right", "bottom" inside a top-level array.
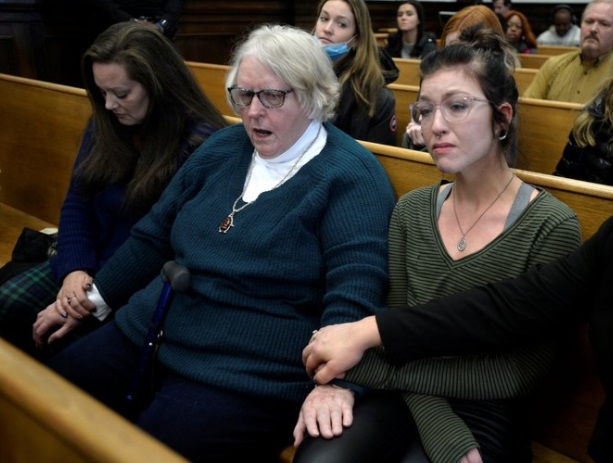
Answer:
[{"left": 126, "top": 260, "right": 190, "bottom": 413}]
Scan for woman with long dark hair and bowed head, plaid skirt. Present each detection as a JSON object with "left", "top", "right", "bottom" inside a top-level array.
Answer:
[{"left": 0, "top": 22, "right": 227, "bottom": 357}]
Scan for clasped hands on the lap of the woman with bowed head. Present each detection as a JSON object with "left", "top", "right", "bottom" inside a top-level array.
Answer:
[{"left": 32, "top": 271, "right": 96, "bottom": 348}]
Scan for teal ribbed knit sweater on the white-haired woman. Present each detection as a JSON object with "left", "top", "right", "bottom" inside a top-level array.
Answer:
[{"left": 96, "top": 124, "right": 394, "bottom": 401}]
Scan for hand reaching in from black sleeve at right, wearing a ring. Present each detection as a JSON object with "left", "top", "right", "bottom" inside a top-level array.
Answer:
[{"left": 302, "top": 316, "right": 381, "bottom": 384}]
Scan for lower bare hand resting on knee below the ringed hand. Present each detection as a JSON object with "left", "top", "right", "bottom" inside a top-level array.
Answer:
[{"left": 294, "top": 385, "right": 354, "bottom": 446}]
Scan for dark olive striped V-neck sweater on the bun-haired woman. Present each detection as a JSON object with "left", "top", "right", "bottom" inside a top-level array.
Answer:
[{"left": 346, "top": 185, "right": 581, "bottom": 463}]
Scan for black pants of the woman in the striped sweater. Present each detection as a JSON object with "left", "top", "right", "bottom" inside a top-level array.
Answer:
[{"left": 294, "top": 392, "right": 532, "bottom": 463}]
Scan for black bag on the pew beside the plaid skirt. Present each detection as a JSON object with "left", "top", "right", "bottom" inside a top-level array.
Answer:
[{"left": 0, "top": 227, "right": 57, "bottom": 285}]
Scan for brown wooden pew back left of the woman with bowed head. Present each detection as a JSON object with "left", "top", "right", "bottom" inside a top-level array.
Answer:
[{"left": 0, "top": 74, "right": 90, "bottom": 224}]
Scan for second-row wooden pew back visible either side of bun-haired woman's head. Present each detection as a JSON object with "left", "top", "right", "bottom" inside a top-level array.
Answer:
[{"left": 388, "top": 84, "right": 583, "bottom": 174}]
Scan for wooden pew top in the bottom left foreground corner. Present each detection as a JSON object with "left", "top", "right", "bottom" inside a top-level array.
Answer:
[{"left": 0, "top": 339, "right": 187, "bottom": 463}]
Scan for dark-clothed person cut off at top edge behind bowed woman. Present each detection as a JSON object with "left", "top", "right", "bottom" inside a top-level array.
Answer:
[{"left": 91, "top": 0, "right": 184, "bottom": 39}]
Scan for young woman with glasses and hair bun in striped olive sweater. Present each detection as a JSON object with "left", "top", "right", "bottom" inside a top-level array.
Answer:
[{"left": 294, "top": 29, "right": 581, "bottom": 463}]
